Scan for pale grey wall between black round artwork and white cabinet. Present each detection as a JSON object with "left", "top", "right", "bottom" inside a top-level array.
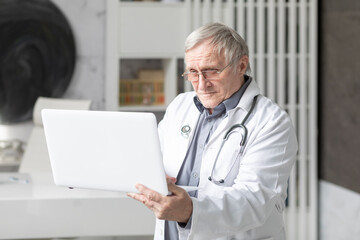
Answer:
[{"left": 52, "top": 0, "right": 106, "bottom": 110}]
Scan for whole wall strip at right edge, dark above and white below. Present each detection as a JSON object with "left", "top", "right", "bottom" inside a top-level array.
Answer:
[{"left": 319, "top": 0, "right": 360, "bottom": 240}]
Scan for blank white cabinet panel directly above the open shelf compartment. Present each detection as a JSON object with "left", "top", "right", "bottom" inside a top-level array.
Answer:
[{"left": 118, "top": 2, "right": 186, "bottom": 57}]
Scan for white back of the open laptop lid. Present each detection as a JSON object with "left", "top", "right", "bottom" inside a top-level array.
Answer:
[{"left": 42, "top": 109, "right": 168, "bottom": 195}]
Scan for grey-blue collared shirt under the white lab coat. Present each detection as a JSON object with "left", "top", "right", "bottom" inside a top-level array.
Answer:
[{"left": 165, "top": 76, "right": 251, "bottom": 240}]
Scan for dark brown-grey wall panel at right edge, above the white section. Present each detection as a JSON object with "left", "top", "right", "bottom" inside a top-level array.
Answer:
[{"left": 319, "top": 0, "right": 360, "bottom": 193}]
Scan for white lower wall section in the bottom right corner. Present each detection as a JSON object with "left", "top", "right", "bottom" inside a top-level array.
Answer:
[{"left": 319, "top": 181, "right": 360, "bottom": 240}]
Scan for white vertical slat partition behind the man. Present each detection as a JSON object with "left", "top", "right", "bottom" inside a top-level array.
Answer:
[{"left": 187, "top": 0, "right": 317, "bottom": 240}]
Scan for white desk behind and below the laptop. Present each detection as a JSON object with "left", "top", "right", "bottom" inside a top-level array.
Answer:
[{"left": 0, "top": 173, "right": 155, "bottom": 239}]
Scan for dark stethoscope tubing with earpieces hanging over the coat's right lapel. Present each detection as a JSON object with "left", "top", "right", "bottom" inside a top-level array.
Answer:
[{"left": 208, "top": 95, "right": 258, "bottom": 184}]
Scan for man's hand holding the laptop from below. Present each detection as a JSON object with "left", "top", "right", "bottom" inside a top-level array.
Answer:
[{"left": 127, "top": 177, "right": 193, "bottom": 223}]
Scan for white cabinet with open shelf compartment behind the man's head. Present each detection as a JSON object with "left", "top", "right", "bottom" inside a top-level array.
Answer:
[{"left": 106, "top": 0, "right": 188, "bottom": 111}]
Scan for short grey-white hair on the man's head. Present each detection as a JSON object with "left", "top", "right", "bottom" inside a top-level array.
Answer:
[{"left": 185, "top": 23, "right": 251, "bottom": 73}]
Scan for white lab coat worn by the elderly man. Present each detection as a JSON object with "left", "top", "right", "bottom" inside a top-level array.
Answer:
[{"left": 155, "top": 80, "right": 297, "bottom": 240}]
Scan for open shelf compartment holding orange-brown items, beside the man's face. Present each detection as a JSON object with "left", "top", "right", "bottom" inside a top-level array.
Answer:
[{"left": 117, "top": 58, "right": 182, "bottom": 111}]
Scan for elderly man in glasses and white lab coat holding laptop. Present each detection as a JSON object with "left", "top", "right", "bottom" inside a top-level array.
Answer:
[{"left": 128, "top": 23, "right": 297, "bottom": 240}]
